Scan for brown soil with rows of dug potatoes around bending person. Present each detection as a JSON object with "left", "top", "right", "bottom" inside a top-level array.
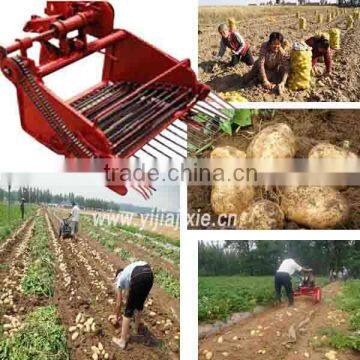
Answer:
[{"left": 0, "top": 209, "right": 180, "bottom": 360}]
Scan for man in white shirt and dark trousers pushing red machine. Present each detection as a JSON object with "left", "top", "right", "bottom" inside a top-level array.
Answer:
[{"left": 275, "top": 258, "right": 312, "bottom": 306}]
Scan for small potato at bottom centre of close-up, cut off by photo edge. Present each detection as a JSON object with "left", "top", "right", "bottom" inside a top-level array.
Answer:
[{"left": 237, "top": 200, "right": 285, "bottom": 230}]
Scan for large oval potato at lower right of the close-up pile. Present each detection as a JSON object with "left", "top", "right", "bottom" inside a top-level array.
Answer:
[{"left": 281, "top": 186, "right": 349, "bottom": 229}]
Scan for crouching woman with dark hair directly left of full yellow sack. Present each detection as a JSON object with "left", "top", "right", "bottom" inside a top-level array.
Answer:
[{"left": 243, "top": 32, "right": 290, "bottom": 95}]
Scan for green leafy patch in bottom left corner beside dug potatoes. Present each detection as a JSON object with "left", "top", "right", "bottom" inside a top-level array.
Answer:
[{"left": 0, "top": 306, "right": 70, "bottom": 360}]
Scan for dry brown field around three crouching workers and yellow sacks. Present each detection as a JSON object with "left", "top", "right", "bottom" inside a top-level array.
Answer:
[{"left": 199, "top": 6, "right": 360, "bottom": 101}]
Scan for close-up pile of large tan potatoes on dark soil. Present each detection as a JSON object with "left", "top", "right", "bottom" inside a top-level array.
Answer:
[{"left": 211, "top": 123, "right": 358, "bottom": 230}]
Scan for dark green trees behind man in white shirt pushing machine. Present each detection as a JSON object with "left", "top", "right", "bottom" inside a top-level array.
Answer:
[{"left": 199, "top": 240, "right": 360, "bottom": 277}]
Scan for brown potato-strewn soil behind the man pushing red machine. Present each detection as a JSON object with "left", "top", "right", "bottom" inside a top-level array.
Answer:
[{"left": 199, "top": 283, "right": 359, "bottom": 360}]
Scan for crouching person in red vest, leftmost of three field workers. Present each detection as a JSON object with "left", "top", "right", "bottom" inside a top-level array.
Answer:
[{"left": 213, "top": 23, "right": 254, "bottom": 66}]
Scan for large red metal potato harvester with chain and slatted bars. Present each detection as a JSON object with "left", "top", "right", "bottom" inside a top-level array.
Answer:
[{"left": 0, "top": 1, "right": 231, "bottom": 195}]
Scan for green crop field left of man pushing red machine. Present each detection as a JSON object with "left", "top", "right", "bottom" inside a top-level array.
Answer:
[{"left": 198, "top": 276, "right": 327, "bottom": 321}]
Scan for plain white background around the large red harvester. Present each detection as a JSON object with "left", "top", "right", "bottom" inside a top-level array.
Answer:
[{"left": 0, "top": 0, "right": 197, "bottom": 172}]
